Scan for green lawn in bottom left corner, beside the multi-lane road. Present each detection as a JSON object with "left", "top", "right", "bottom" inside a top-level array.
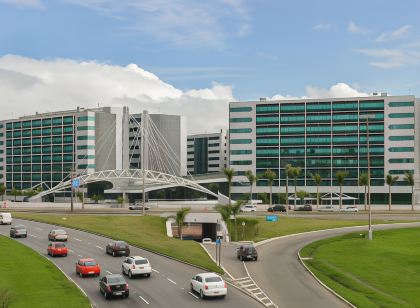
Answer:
[{"left": 0, "top": 236, "right": 90, "bottom": 308}]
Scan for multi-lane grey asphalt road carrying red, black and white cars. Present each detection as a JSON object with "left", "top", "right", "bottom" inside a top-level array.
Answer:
[{"left": 0, "top": 219, "right": 260, "bottom": 308}]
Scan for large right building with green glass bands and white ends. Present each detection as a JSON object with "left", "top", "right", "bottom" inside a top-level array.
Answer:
[{"left": 229, "top": 94, "right": 420, "bottom": 204}]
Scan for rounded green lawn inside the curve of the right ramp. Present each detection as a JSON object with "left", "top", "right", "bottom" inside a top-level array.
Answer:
[{"left": 301, "top": 228, "right": 420, "bottom": 307}]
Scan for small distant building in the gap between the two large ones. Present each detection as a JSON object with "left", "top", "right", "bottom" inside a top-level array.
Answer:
[{"left": 187, "top": 130, "right": 227, "bottom": 175}]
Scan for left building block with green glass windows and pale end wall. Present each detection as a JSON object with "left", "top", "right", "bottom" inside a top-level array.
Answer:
[{"left": 0, "top": 107, "right": 129, "bottom": 190}]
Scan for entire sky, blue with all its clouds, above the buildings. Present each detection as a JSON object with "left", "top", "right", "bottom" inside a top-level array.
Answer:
[{"left": 0, "top": 0, "right": 420, "bottom": 133}]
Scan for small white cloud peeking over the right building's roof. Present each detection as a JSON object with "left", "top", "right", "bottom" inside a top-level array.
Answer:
[{"left": 271, "top": 82, "right": 369, "bottom": 100}]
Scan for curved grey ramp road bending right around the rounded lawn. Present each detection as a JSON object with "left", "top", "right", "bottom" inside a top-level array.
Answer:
[{"left": 245, "top": 222, "right": 420, "bottom": 308}]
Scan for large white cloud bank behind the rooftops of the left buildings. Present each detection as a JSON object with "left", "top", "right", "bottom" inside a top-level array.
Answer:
[{"left": 0, "top": 55, "right": 234, "bottom": 133}]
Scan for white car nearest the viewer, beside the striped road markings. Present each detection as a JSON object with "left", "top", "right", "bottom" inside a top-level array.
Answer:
[{"left": 191, "top": 273, "right": 227, "bottom": 299}]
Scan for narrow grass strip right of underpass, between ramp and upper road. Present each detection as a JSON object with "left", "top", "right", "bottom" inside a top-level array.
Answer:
[{"left": 231, "top": 216, "right": 406, "bottom": 242}]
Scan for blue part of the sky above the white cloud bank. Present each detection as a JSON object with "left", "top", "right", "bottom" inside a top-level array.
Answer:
[{"left": 0, "top": 0, "right": 420, "bottom": 132}]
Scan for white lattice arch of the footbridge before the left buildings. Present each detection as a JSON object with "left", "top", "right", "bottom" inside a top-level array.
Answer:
[{"left": 30, "top": 169, "right": 219, "bottom": 200}]
